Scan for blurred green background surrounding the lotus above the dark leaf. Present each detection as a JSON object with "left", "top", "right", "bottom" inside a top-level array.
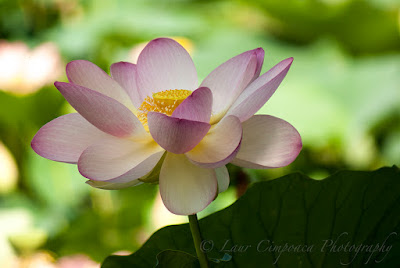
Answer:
[{"left": 0, "top": 0, "right": 400, "bottom": 268}]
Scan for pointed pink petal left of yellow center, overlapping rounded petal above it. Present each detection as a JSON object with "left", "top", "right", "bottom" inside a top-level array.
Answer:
[{"left": 54, "top": 82, "right": 146, "bottom": 137}]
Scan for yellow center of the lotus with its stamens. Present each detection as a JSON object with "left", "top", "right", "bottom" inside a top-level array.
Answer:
[{"left": 137, "top": 89, "right": 192, "bottom": 131}]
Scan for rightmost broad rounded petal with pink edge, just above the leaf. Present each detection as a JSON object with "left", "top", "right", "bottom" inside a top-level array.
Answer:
[{"left": 232, "top": 115, "right": 302, "bottom": 169}]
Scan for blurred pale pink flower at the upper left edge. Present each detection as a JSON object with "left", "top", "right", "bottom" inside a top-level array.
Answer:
[{"left": 0, "top": 41, "right": 62, "bottom": 95}]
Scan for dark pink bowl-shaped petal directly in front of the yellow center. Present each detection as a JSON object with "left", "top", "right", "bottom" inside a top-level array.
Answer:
[{"left": 147, "top": 112, "right": 210, "bottom": 154}]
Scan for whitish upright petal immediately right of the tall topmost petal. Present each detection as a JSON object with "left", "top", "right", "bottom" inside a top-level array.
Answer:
[{"left": 200, "top": 50, "right": 257, "bottom": 123}]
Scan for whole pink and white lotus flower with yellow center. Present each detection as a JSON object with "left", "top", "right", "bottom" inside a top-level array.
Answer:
[{"left": 32, "top": 38, "right": 302, "bottom": 215}]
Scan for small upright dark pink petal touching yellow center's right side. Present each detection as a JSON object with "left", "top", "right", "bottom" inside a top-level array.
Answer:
[{"left": 172, "top": 87, "right": 212, "bottom": 123}]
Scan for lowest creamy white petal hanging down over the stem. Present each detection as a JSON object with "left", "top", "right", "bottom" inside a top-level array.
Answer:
[{"left": 160, "top": 153, "right": 218, "bottom": 215}]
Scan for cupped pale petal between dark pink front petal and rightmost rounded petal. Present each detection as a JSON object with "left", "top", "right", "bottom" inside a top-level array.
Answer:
[{"left": 186, "top": 116, "right": 242, "bottom": 168}]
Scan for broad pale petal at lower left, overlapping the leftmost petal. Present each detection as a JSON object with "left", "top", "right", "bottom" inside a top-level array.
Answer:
[{"left": 78, "top": 137, "right": 164, "bottom": 183}]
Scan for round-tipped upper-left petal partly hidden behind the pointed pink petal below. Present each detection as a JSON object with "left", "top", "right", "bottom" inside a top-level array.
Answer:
[{"left": 67, "top": 60, "right": 133, "bottom": 108}]
